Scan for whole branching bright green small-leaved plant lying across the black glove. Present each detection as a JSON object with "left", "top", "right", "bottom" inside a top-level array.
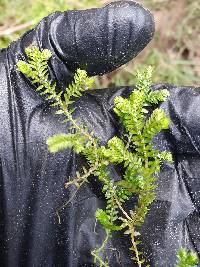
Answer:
[{"left": 17, "top": 46, "right": 198, "bottom": 267}]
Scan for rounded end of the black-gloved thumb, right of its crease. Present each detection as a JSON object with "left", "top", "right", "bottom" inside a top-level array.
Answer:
[{"left": 51, "top": 1, "right": 154, "bottom": 75}]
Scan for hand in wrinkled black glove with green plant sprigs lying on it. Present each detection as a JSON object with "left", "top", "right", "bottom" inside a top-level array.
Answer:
[{"left": 0, "top": 1, "right": 200, "bottom": 267}]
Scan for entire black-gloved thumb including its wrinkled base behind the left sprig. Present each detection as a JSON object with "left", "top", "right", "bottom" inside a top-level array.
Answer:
[{"left": 12, "top": 1, "right": 154, "bottom": 85}]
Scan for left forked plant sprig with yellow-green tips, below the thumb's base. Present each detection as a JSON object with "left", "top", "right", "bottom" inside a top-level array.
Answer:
[{"left": 17, "top": 45, "right": 103, "bottom": 191}]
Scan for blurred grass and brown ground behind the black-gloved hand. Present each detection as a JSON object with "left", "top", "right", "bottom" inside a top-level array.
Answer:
[{"left": 0, "top": 0, "right": 200, "bottom": 87}]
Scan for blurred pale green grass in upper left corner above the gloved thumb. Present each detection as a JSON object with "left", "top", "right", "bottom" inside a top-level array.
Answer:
[{"left": 0, "top": 0, "right": 101, "bottom": 48}]
